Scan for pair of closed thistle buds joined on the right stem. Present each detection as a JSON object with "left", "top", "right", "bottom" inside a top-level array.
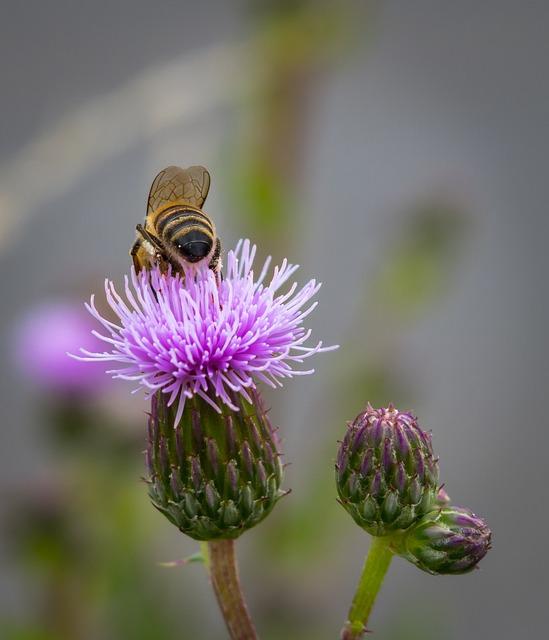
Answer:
[{"left": 336, "top": 405, "right": 491, "bottom": 574}]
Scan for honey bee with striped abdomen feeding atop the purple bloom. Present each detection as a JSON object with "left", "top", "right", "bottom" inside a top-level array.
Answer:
[{"left": 130, "top": 166, "right": 221, "bottom": 276}]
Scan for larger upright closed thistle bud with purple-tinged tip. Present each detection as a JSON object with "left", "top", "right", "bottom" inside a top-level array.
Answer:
[{"left": 336, "top": 405, "right": 439, "bottom": 536}]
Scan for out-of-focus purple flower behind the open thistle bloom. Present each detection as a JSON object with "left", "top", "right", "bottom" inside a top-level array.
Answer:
[{"left": 13, "top": 302, "right": 104, "bottom": 393}]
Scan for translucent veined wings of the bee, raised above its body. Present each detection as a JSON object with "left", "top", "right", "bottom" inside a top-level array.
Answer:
[{"left": 147, "top": 166, "right": 210, "bottom": 216}]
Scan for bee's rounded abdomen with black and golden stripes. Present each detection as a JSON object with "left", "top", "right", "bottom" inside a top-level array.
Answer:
[{"left": 154, "top": 207, "right": 215, "bottom": 262}]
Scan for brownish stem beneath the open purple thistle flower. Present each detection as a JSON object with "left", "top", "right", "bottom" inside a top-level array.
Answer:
[{"left": 208, "top": 540, "right": 257, "bottom": 640}]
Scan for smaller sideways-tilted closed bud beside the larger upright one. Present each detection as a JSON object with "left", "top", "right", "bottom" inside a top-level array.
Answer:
[{"left": 392, "top": 507, "right": 492, "bottom": 575}]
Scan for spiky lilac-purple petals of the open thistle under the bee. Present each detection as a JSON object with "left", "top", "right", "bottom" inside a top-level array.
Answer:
[{"left": 75, "top": 240, "right": 336, "bottom": 425}]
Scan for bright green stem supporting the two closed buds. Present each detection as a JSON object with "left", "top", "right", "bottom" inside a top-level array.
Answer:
[{"left": 341, "top": 537, "right": 393, "bottom": 640}]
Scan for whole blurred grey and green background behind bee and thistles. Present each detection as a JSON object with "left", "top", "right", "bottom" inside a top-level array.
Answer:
[{"left": 0, "top": 0, "right": 549, "bottom": 640}]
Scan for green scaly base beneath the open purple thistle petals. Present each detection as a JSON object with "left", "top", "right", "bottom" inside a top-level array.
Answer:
[{"left": 145, "top": 391, "right": 284, "bottom": 540}]
